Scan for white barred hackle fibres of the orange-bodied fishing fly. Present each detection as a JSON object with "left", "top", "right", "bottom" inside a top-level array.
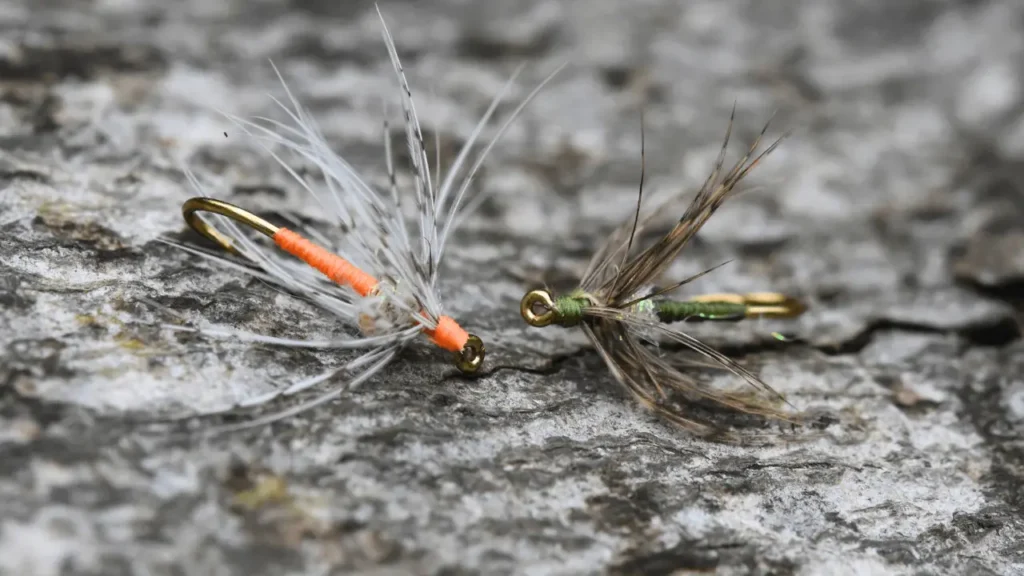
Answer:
[{"left": 158, "top": 8, "right": 561, "bottom": 431}]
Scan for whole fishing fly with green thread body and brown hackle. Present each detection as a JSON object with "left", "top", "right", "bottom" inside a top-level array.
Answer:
[{"left": 520, "top": 110, "right": 805, "bottom": 440}]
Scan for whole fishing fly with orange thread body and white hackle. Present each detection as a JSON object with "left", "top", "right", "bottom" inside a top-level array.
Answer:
[{"left": 161, "top": 5, "right": 558, "bottom": 431}]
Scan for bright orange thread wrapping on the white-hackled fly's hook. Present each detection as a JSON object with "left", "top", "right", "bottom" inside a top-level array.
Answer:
[{"left": 273, "top": 228, "right": 469, "bottom": 353}]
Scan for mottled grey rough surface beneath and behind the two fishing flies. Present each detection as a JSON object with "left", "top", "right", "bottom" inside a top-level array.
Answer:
[{"left": 0, "top": 0, "right": 1024, "bottom": 576}]
